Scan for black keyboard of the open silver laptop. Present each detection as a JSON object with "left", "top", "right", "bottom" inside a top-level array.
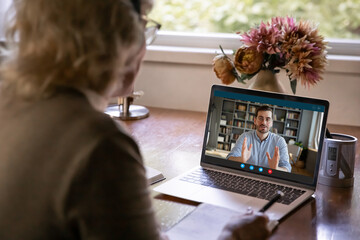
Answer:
[{"left": 180, "top": 169, "right": 305, "bottom": 205}]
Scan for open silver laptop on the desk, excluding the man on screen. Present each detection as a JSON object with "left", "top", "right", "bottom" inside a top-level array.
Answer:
[{"left": 154, "top": 85, "right": 329, "bottom": 220}]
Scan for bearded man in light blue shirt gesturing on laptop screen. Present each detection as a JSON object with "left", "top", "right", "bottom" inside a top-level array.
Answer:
[{"left": 227, "top": 105, "right": 291, "bottom": 172}]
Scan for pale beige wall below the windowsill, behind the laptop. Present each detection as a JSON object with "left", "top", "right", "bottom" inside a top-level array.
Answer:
[{"left": 135, "top": 51, "right": 360, "bottom": 126}]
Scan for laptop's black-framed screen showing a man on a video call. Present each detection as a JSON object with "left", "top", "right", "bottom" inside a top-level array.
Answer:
[{"left": 202, "top": 85, "right": 329, "bottom": 186}]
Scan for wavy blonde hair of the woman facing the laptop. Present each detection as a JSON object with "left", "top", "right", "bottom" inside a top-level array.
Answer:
[{"left": 1, "top": 0, "right": 147, "bottom": 97}]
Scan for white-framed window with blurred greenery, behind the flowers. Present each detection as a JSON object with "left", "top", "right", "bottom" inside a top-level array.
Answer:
[{"left": 145, "top": 0, "right": 360, "bottom": 68}]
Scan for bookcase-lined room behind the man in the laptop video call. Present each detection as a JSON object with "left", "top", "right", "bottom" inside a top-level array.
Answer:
[{"left": 205, "top": 96, "right": 323, "bottom": 177}]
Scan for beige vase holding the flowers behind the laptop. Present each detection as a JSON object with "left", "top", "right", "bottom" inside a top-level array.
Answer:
[{"left": 249, "top": 70, "right": 286, "bottom": 93}]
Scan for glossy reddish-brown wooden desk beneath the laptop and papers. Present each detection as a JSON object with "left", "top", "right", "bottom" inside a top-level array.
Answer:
[{"left": 124, "top": 108, "right": 360, "bottom": 240}]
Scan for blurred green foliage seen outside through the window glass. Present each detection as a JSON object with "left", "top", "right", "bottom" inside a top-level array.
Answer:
[{"left": 150, "top": 0, "right": 360, "bottom": 39}]
